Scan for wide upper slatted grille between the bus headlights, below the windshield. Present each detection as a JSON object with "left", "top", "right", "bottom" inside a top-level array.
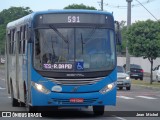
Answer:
[{"left": 47, "top": 77, "right": 104, "bottom": 85}]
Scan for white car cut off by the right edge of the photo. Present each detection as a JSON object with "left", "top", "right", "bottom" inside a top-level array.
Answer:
[{"left": 153, "top": 65, "right": 160, "bottom": 82}]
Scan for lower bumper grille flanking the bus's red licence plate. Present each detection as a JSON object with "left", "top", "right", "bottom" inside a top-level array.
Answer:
[{"left": 52, "top": 98, "right": 97, "bottom": 105}]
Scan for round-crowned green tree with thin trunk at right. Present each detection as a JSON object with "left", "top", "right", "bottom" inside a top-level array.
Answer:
[{"left": 126, "top": 20, "right": 160, "bottom": 84}]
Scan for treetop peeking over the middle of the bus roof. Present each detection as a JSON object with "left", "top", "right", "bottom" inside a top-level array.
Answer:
[{"left": 64, "top": 4, "right": 97, "bottom": 10}]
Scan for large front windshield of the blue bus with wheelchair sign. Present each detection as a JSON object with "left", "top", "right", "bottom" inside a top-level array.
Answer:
[{"left": 34, "top": 26, "right": 116, "bottom": 72}]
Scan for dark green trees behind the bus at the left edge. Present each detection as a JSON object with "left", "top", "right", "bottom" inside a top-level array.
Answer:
[{"left": 0, "top": 7, "right": 32, "bottom": 54}]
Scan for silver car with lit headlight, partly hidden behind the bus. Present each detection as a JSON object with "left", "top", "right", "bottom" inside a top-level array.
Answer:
[{"left": 117, "top": 66, "right": 131, "bottom": 90}]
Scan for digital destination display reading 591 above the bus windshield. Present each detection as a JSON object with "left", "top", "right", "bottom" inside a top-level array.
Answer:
[{"left": 38, "top": 13, "right": 113, "bottom": 24}]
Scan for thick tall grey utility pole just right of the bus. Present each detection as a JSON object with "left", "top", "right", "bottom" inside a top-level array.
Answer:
[{"left": 126, "top": 0, "right": 133, "bottom": 71}]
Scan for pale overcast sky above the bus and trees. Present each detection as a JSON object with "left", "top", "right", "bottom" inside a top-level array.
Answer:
[{"left": 0, "top": 0, "right": 160, "bottom": 23}]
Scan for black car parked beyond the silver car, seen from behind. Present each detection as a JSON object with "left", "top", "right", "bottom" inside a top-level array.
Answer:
[{"left": 124, "top": 64, "right": 144, "bottom": 80}]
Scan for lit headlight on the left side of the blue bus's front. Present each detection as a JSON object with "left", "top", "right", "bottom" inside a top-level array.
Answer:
[{"left": 32, "top": 82, "right": 51, "bottom": 94}]
